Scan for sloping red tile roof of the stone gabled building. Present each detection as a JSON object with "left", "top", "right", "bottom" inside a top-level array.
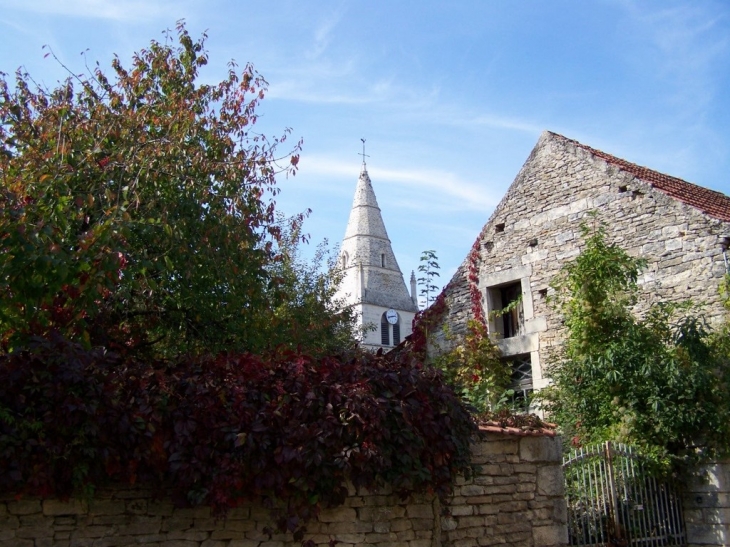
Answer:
[{"left": 553, "top": 133, "right": 730, "bottom": 222}]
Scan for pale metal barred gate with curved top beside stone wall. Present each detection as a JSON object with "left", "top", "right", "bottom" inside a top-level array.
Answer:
[{"left": 563, "top": 442, "right": 686, "bottom": 547}]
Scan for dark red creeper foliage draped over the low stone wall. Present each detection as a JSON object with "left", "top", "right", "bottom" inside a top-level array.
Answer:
[{"left": 0, "top": 336, "right": 475, "bottom": 531}]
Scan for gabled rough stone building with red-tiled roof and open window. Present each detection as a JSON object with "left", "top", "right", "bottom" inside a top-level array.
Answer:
[{"left": 438, "top": 132, "right": 730, "bottom": 398}]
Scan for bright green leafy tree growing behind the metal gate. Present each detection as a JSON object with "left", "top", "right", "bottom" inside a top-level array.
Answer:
[{"left": 538, "top": 220, "right": 730, "bottom": 464}]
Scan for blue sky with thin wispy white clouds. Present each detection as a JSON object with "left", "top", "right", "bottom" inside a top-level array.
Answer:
[{"left": 0, "top": 0, "right": 730, "bottom": 300}]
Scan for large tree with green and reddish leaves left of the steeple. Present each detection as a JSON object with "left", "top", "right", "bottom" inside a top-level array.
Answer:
[{"left": 0, "top": 24, "right": 310, "bottom": 355}]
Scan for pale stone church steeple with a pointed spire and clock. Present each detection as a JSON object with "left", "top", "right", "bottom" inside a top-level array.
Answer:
[{"left": 338, "top": 162, "right": 418, "bottom": 350}]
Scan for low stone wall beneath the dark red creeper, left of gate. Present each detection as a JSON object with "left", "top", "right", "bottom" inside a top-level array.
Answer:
[{"left": 0, "top": 433, "right": 568, "bottom": 547}]
